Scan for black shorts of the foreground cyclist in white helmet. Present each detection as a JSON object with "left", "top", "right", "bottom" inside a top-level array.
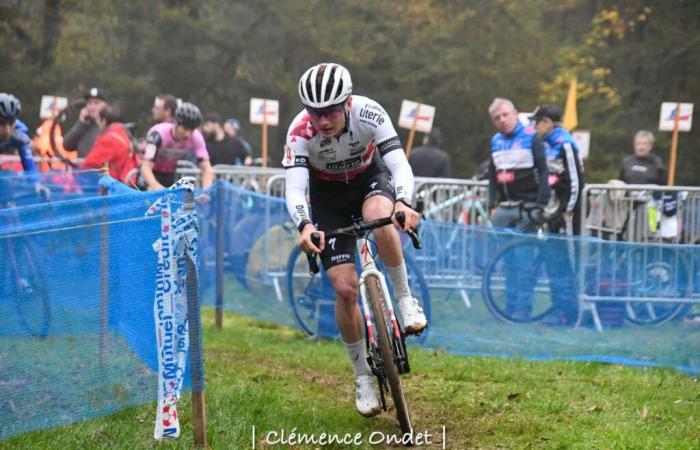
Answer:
[{"left": 309, "top": 166, "right": 396, "bottom": 270}]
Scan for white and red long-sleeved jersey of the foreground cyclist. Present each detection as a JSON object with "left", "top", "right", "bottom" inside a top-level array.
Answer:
[{"left": 282, "top": 95, "right": 414, "bottom": 226}]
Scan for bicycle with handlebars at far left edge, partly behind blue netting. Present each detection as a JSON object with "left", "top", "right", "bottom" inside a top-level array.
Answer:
[{"left": 0, "top": 176, "right": 51, "bottom": 338}]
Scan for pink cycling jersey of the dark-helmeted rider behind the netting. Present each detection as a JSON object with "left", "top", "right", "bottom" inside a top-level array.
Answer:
[{"left": 143, "top": 122, "right": 209, "bottom": 186}]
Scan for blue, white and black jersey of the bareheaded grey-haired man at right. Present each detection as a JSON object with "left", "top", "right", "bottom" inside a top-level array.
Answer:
[{"left": 489, "top": 123, "right": 549, "bottom": 208}]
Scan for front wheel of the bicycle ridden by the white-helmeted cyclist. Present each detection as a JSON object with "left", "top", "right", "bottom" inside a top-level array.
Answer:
[{"left": 365, "top": 275, "right": 411, "bottom": 444}]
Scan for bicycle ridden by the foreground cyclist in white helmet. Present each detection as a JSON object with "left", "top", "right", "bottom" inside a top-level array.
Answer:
[{"left": 290, "top": 213, "right": 425, "bottom": 438}]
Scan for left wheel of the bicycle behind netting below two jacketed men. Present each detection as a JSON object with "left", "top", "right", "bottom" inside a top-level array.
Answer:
[{"left": 482, "top": 241, "right": 554, "bottom": 324}]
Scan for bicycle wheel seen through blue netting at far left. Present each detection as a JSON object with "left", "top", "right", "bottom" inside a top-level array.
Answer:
[{"left": 8, "top": 239, "right": 51, "bottom": 337}]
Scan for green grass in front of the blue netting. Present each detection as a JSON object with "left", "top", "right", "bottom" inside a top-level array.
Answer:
[{"left": 0, "top": 309, "right": 700, "bottom": 449}]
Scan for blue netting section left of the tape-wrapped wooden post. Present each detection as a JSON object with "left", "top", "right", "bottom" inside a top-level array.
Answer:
[{"left": 0, "top": 182, "right": 197, "bottom": 439}]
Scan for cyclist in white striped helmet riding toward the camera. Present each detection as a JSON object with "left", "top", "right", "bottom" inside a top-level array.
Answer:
[{"left": 282, "top": 63, "right": 427, "bottom": 417}]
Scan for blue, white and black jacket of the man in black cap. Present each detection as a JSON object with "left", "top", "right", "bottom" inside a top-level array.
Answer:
[{"left": 542, "top": 126, "right": 583, "bottom": 213}]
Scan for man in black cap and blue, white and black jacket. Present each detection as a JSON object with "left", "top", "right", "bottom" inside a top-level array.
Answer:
[{"left": 531, "top": 104, "right": 583, "bottom": 234}]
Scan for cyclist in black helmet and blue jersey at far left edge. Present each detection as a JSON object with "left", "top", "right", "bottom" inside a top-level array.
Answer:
[{"left": 0, "top": 93, "right": 36, "bottom": 172}]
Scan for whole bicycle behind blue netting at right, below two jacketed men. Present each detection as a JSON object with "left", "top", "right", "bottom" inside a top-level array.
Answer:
[{"left": 482, "top": 201, "right": 691, "bottom": 329}]
